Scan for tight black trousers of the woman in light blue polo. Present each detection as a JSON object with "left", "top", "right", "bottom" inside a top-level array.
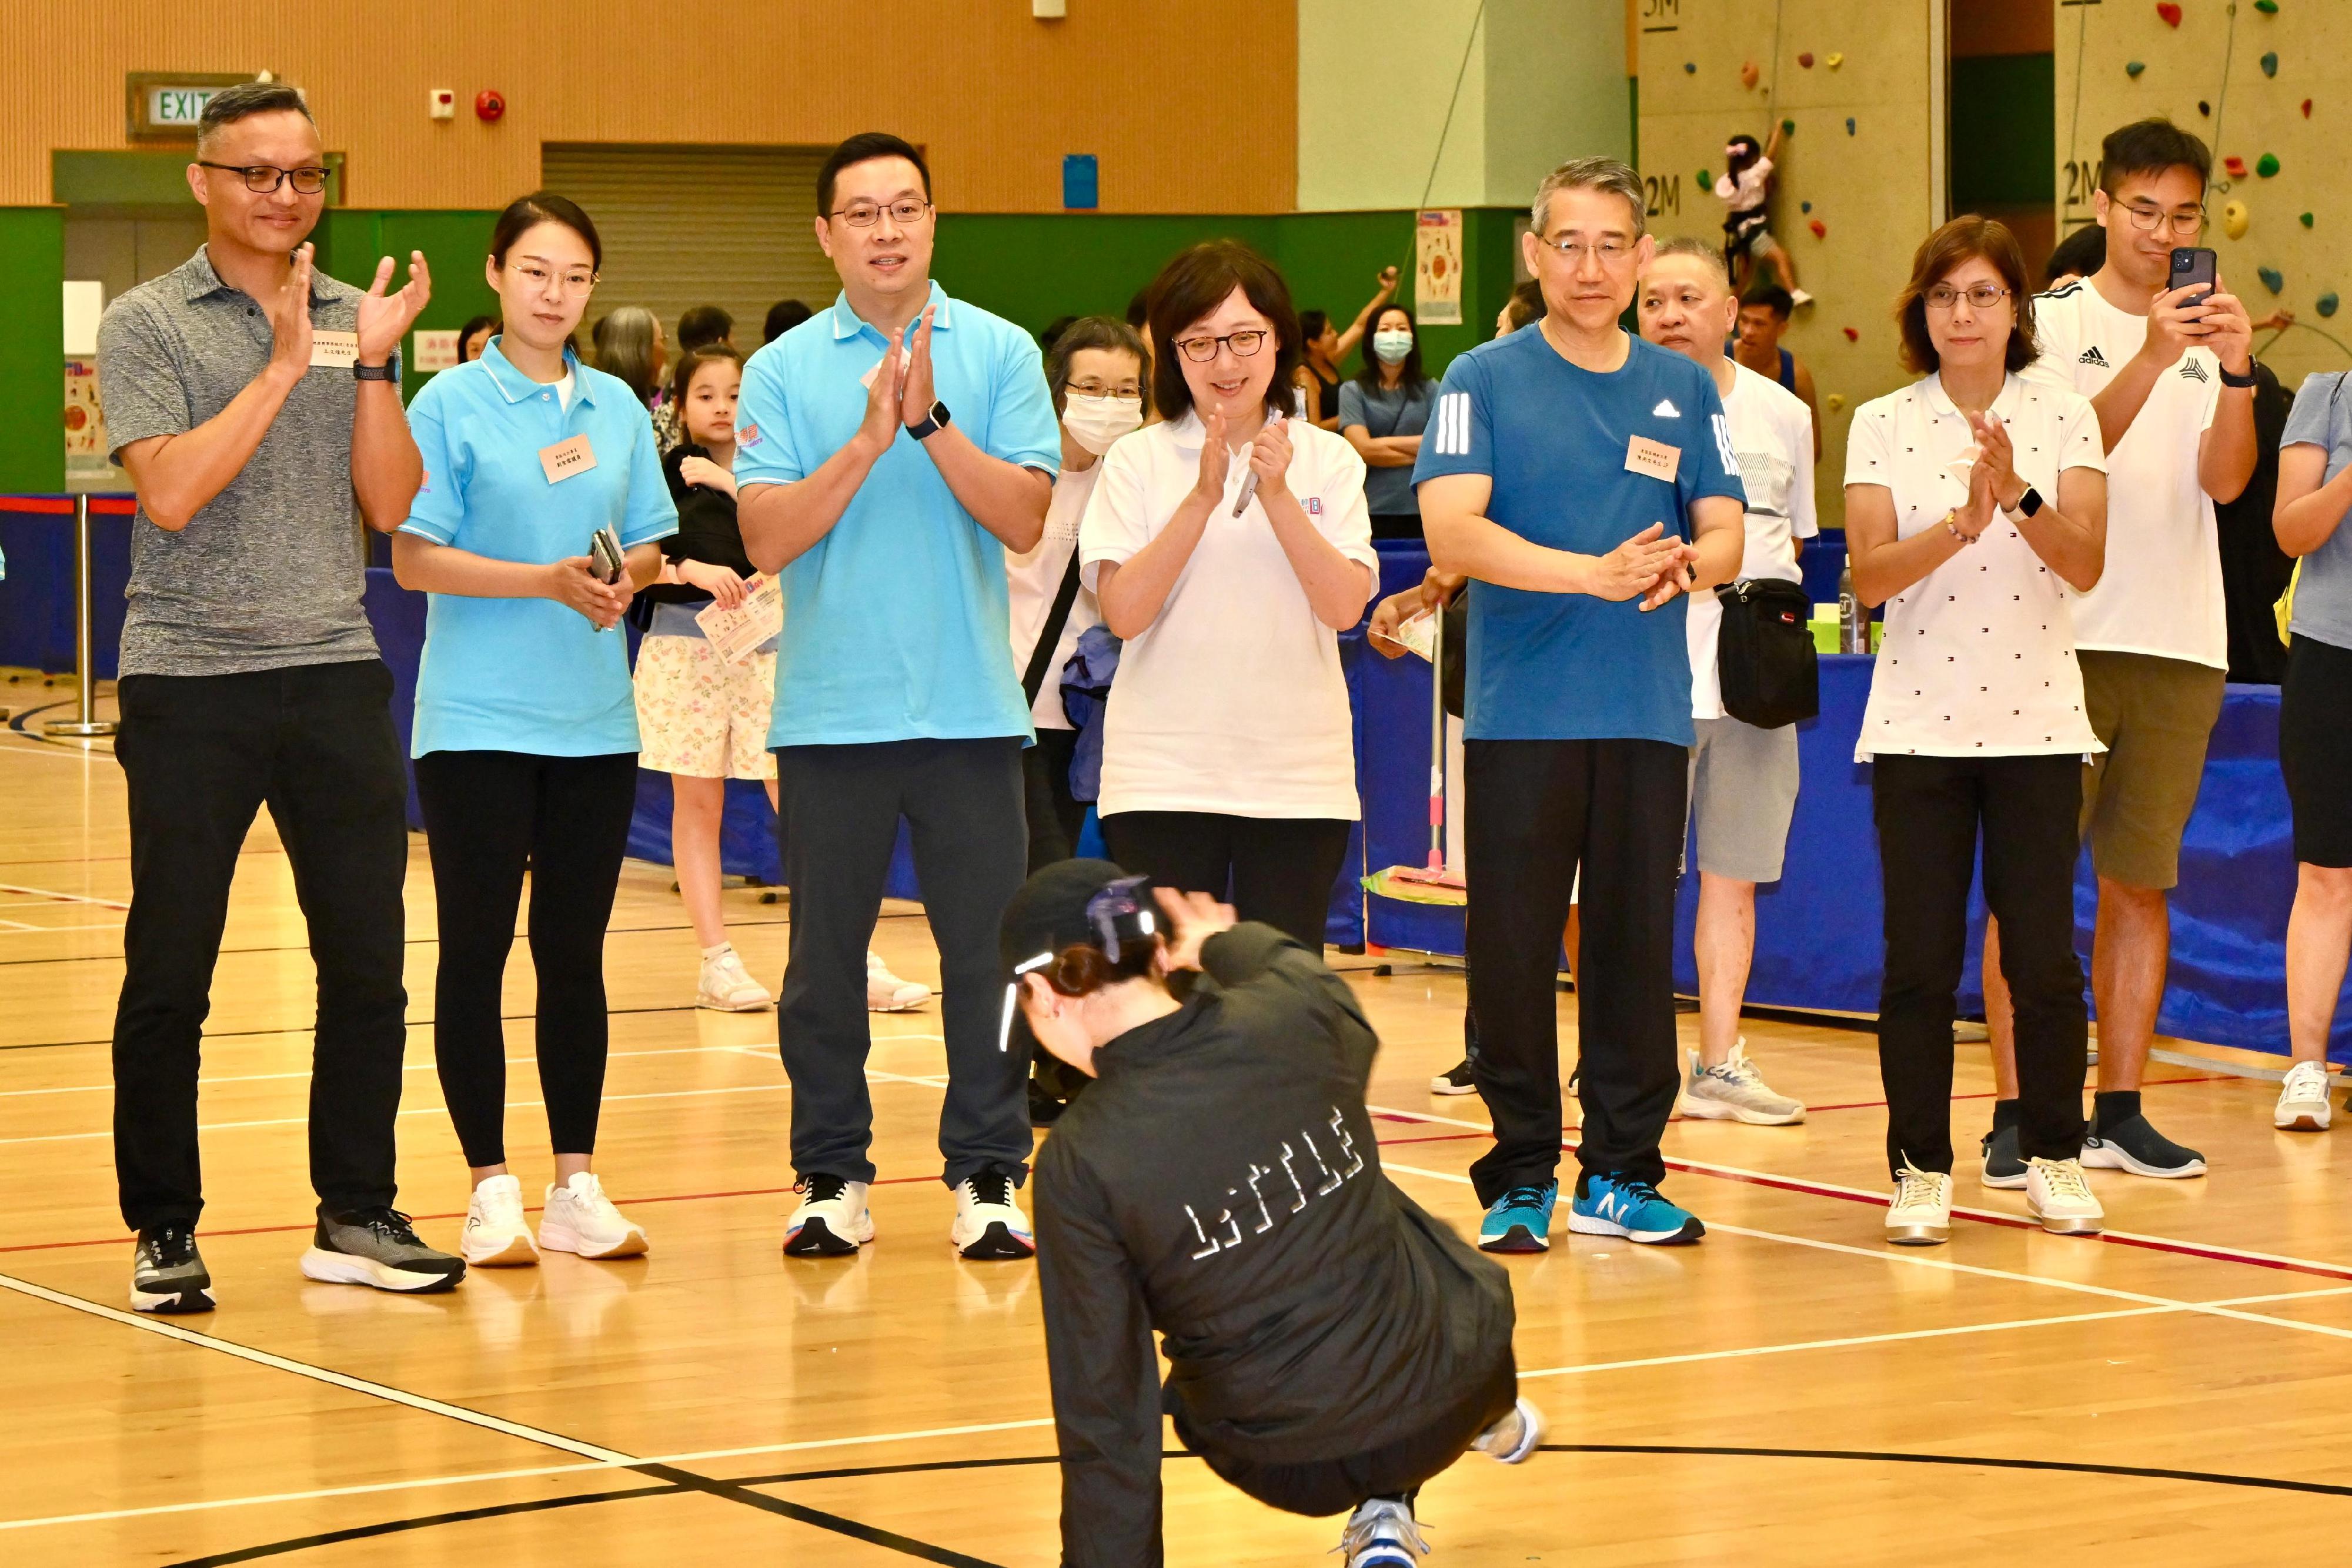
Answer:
[{"left": 416, "top": 753, "right": 637, "bottom": 1166}]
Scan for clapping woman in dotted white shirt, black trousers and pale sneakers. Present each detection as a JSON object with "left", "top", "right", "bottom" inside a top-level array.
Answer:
[{"left": 1846, "top": 216, "right": 2107, "bottom": 1246}]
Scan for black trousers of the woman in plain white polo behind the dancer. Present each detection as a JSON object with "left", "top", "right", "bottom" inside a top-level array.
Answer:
[{"left": 1103, "top": 811, "right": 1355, "bottom": 952}]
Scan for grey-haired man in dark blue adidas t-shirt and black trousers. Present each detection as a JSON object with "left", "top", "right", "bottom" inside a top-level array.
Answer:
[{"left": 1414, "top": 158, "right": 1745, "bottom": 1251}]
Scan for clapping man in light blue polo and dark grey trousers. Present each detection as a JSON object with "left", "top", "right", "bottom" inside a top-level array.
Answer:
[{"left": 734, "top": 132, "right": 1061, "bottom": 1258}]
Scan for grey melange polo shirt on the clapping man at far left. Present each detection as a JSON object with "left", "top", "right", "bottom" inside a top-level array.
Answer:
[{"left": 99, "top": 247, "right": 376, "bottom": 675}]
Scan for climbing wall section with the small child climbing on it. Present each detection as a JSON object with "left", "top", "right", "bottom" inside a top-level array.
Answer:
[{"left": 1632, "top": 0, "right": 1945, "bottom": 527}]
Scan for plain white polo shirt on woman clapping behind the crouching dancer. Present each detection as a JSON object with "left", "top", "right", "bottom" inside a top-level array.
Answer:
[{"left": 1077, "top": 414, "right": 1381, "bottom": 820}]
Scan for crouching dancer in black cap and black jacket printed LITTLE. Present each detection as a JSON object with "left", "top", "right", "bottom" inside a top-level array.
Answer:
[{"left": 1004, "top": 860, "right": 1543, "bottom": 1568}]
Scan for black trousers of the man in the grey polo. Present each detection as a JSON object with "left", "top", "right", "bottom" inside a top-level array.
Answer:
[{"left": 115, "top": 658, "right": 409, "bottom": 1229}]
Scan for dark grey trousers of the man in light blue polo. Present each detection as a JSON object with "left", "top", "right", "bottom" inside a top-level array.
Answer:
[{"left": 776, "top": 736, "right": 1030, "bottom": 1187}]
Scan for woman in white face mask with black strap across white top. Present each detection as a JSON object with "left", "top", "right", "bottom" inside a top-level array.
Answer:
[{"left": 1004, "top": 315, "right": 1148, "bottom": 870}]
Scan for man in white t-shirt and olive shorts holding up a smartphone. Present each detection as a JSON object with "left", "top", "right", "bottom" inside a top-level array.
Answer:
[{"left": 1985, "top": 120, "right": 2256, "bottom": 1187}]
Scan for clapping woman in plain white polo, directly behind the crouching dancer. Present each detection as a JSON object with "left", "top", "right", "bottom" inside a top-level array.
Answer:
[{"left": 1080, "top": 240, "right": 1378, "bottom": 952}]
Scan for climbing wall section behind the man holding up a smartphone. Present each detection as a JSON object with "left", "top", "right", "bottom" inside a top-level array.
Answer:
[{"left": 2053, "top": 0, "right": 2352, "bottom": 390}]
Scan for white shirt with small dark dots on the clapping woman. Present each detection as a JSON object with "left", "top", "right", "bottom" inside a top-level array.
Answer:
[{"left": 1846, "top": 376, "right": 2107, "bottom": 762}]
